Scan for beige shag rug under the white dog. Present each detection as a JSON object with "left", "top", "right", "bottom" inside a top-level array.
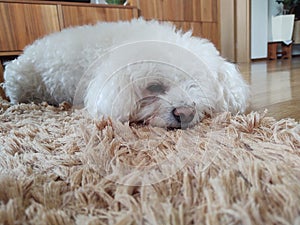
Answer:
[{"left": 0, "top": 97, "right": 300, "bottom": 225}]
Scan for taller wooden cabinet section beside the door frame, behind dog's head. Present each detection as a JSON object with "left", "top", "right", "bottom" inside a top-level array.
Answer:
[{"left": 132, "top": 0, "right": 220, "bottom": 49}]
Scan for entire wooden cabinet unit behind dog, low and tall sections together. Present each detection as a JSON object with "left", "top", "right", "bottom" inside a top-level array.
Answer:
[{"left": 0, "top": 0, "right": 220, "bottom": 53}]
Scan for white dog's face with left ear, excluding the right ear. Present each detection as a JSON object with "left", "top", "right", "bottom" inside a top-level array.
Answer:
[{"left": 85, "top": 63, "right": 214, "bottom": 128}]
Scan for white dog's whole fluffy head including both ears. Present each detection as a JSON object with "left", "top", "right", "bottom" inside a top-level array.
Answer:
[{"left": 79, "top": 39, "right": 248, "bottom": 128}]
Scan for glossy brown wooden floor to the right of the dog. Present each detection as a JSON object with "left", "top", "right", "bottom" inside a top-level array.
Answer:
[{"left": 239, "top": 57, "right": 300, "bottom": 122}]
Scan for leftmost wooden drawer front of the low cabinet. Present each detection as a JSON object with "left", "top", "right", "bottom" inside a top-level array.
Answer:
[{"left": 0, "top": 3, "right": 60, "bottom": 51}]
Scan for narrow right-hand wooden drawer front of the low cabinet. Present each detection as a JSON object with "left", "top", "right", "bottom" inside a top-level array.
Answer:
[{"left": 62, "top": 5, "right": 138, "bottom": 27}]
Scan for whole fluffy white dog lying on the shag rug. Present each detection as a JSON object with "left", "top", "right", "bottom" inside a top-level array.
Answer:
[{"left": 3, "top": 19, "right": 249, "bottom": 128}]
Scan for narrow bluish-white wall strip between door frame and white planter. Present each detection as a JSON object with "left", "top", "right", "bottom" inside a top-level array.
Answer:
[{"left": 251, "top": 0, "right": 268, "bottom": 59}]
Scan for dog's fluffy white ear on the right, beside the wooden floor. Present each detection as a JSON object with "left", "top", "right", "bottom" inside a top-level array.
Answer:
[{"left": 218, "top": 61, "right": 250, "bottom": 113}]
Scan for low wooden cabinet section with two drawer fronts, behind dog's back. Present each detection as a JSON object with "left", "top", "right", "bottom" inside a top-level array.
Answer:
[{"left": 0, "top": 0, "right": 138, "bottom": 56}]
